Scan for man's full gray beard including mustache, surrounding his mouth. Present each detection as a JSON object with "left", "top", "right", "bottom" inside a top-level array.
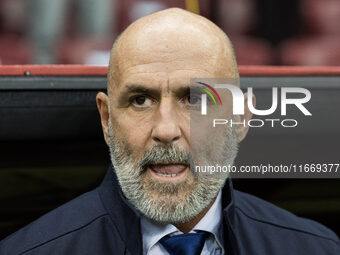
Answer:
[{"left": 109, "top": 121, "right": 238, "bottom": 224}]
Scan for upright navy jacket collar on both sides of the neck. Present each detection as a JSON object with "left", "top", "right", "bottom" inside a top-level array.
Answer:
[{"left": 98, "top": 165, "right": 235, "bottom": 254}]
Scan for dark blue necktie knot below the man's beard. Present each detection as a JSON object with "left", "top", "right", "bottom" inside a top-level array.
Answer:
[{"left": 159, "top": 231, "right": 209, "bottom": 255}]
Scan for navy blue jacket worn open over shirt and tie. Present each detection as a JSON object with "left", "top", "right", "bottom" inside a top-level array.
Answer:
[{"left": 0, "top": 167, "right": 340, "bottom": 255}]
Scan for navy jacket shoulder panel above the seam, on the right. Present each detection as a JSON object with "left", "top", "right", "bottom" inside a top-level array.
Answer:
[{"left": 234, "top": 190, "right": 340, "bottom": 245}]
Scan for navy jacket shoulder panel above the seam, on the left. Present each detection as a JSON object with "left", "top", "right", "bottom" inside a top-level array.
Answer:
[{"left": 0, "top": 189, "right": 107, "bottom": 254}]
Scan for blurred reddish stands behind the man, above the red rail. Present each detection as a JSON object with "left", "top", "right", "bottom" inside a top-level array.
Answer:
[{"left": 0, "top": 0, "right": 340, "bottom": 65}]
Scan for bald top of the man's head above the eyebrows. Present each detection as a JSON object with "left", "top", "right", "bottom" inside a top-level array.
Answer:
[{"left": 108, "top": 8, "right": 238, "bottom": 90}]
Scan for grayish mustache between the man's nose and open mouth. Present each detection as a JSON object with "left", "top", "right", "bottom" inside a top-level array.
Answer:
[{"left": 139, "top": 144, "right": 192, "bottom": 170}]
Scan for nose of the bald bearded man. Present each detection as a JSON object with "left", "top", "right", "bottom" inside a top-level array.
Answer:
[{"left": 151, "top": 99, "right": 182, "bottom": 145}]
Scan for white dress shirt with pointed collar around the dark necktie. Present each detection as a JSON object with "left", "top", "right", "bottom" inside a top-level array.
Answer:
[{"left": 141, "top": 191, "right": 224, "bottom": 255}]
